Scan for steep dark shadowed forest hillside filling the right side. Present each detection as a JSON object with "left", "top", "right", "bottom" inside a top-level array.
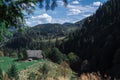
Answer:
[{"left": 60, "top": 0, "right": 120, "bottom": 77}]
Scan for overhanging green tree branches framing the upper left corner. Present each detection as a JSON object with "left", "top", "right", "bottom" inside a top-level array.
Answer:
[{"left": 0, "top": 0, "right": 67, "bottom": 43}]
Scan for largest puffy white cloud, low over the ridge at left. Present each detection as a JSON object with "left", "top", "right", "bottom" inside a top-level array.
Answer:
[{"left": 26, "top": 13, "right": 52, "bottom": 26}]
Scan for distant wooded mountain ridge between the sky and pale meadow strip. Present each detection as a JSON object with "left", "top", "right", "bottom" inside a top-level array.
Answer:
[{"left": 27, "top": 21, "right": 83, "bottom": 37}]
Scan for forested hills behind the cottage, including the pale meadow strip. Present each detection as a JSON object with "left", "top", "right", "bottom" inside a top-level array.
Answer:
[{"left": 4, "top": 21, "right": 84, "bottom": 53}]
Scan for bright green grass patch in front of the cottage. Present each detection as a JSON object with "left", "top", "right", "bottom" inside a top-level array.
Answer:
[{"left": 0, "top": 57, "right": 43, "bottom": 71}]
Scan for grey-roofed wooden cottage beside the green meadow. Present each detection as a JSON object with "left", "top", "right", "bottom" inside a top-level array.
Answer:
[{"left": 26, "top": 50, "right": 43, "bottom": 59}]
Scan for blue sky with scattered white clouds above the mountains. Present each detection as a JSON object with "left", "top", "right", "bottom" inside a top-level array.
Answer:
[{"left": 25, "top": 0, "right": 106, "bottom": 27}]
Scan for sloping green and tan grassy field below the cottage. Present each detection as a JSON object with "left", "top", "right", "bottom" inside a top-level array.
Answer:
[{"left": 0, "top": 57, "right": 73, "bottom": 80}]
